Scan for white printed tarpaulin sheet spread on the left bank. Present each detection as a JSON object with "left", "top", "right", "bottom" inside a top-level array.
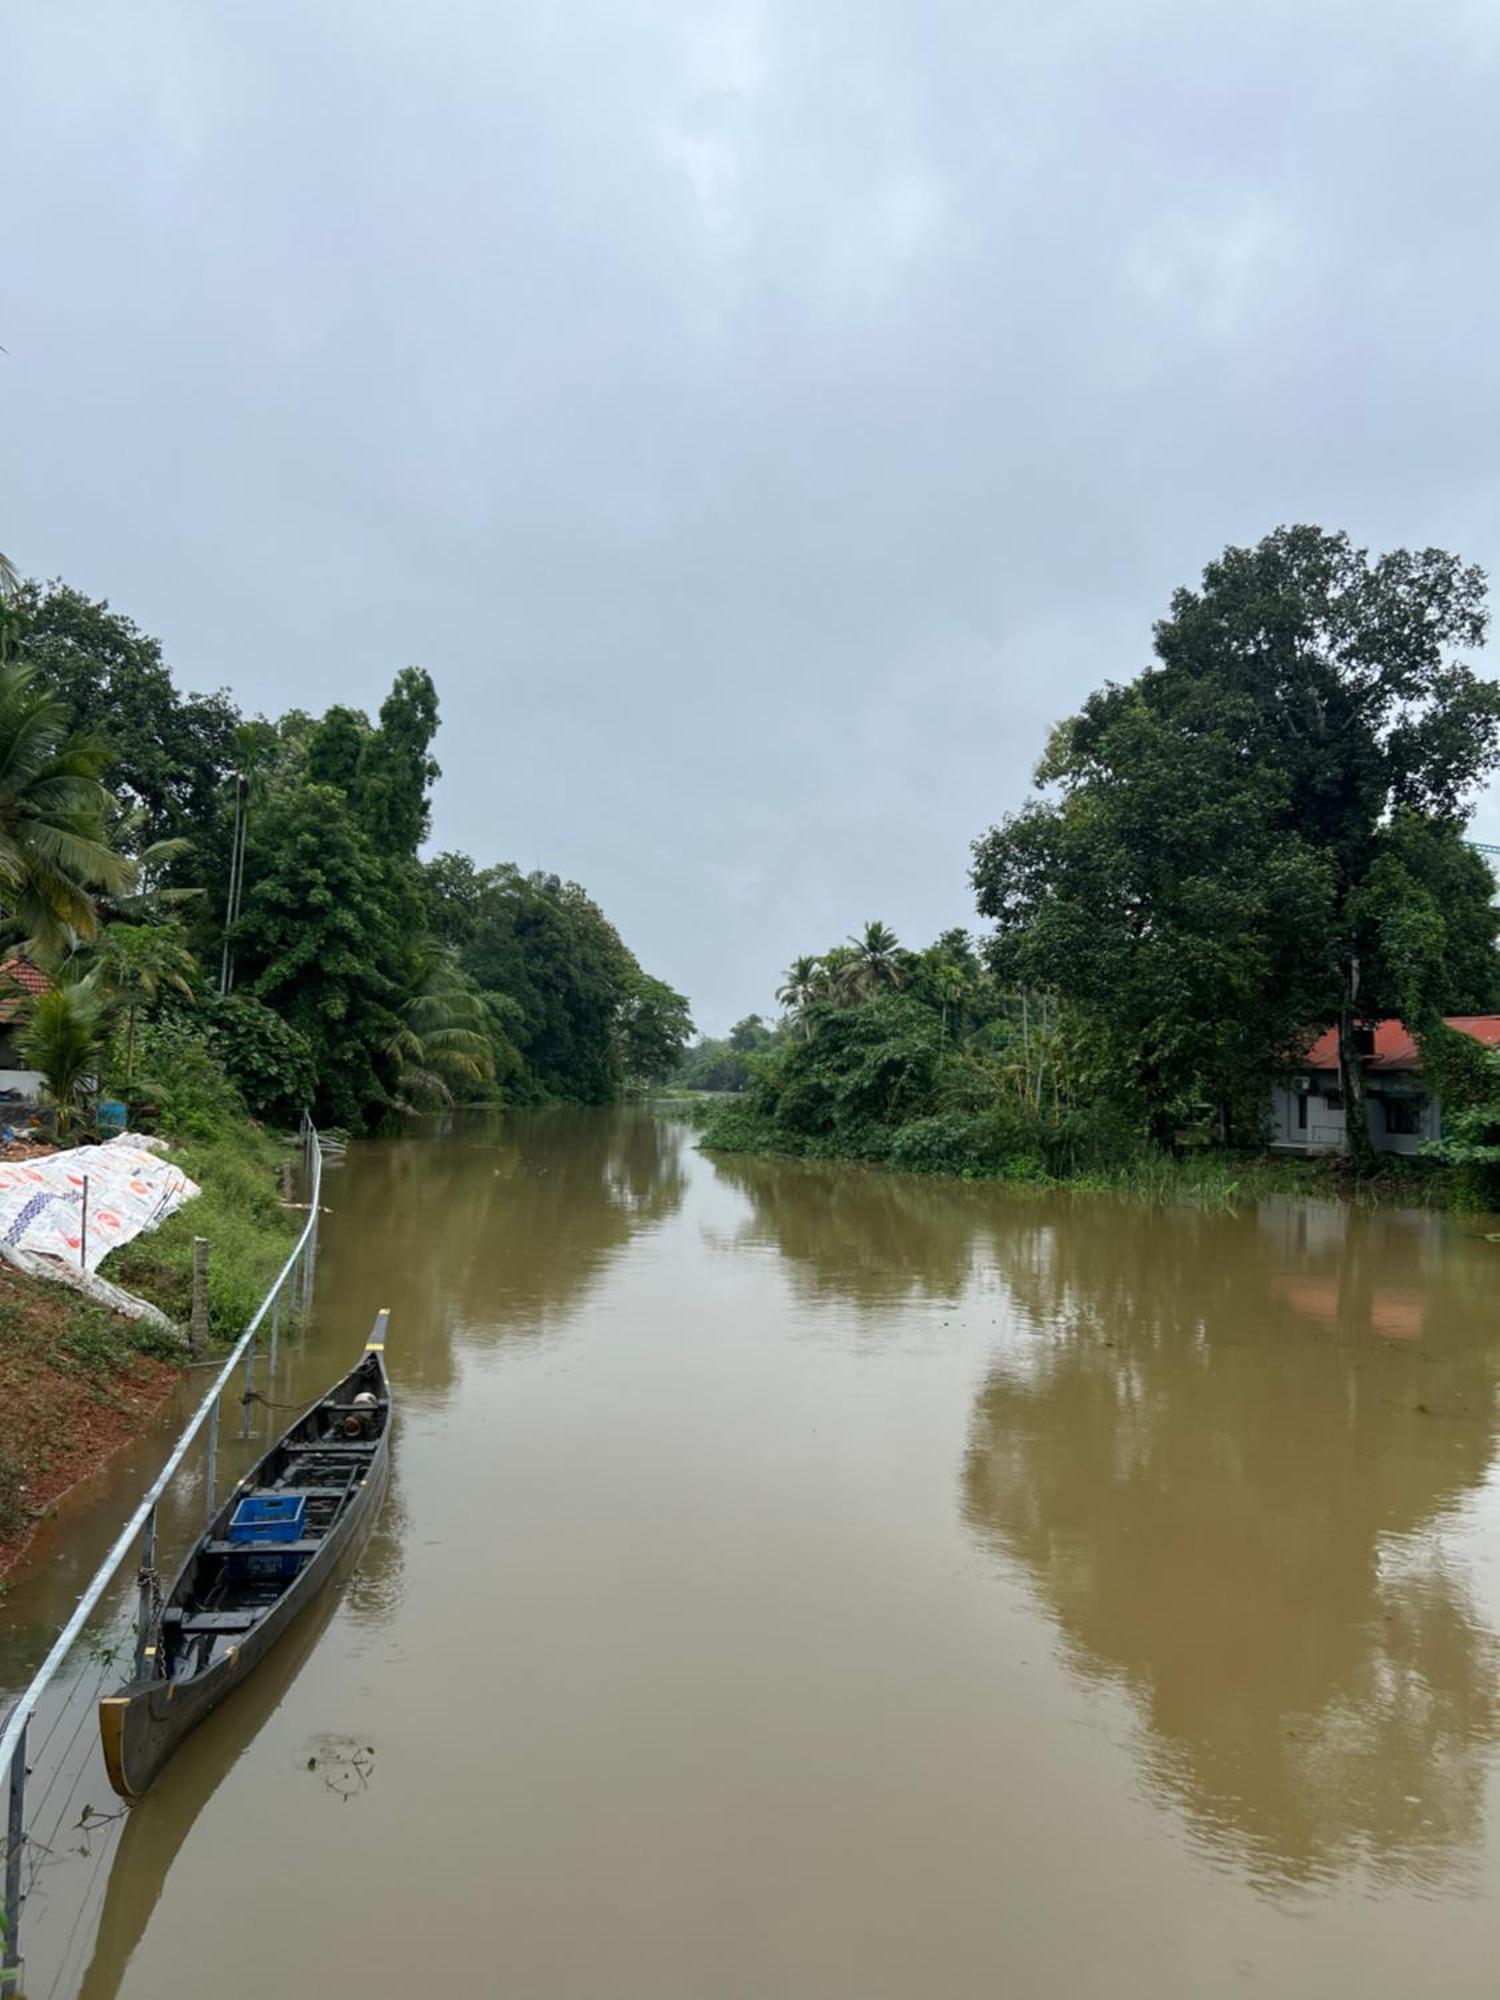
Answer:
[{"left": 0, "top": 1132, "right": 198, "bottom": 1276}]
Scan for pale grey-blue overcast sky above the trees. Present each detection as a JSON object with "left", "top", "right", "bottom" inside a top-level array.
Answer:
[{"left": 0, "top": 0, "right": 1500, "bottom": 1030}]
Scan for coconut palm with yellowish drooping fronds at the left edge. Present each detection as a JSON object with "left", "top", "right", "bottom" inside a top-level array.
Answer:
[{"left": 0, "top": 662, "right": 134, "bottom": 960}]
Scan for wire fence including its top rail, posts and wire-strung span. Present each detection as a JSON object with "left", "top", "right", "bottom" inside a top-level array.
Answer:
[{"left": 0, "top": 1120, "right": 322, "bottom": 2000}]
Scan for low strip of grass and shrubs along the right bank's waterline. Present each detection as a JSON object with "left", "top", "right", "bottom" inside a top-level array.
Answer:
[{"left": 692, "top": 1096, "right": 1476, "bottom": 1208}]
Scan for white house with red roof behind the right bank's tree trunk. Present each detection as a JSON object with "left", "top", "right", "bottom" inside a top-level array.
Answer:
[{"left": 1270, "top": 1014, "right": 1500, "bottom": 1152}]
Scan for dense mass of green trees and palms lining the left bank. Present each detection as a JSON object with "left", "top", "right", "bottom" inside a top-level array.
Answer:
[{"left": 0, "top": 574, "right": 692, "bottom": 1136}]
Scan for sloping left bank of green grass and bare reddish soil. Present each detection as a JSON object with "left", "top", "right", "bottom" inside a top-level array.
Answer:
[{"left": 0, "top": 1118, "right": 302, "bottom": 1574}]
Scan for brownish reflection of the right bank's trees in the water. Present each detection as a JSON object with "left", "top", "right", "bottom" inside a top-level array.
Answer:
[{"left": 714, "top": 1158, "right": 1500, "bottom": 1886}]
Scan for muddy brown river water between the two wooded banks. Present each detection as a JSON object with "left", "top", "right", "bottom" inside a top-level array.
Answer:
[{"left": 0, "top": 1110, "right": 1500, "bottom": 2000}]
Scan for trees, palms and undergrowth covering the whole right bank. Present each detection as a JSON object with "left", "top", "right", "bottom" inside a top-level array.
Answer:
[{"left": 704, "top": 528, "right": 1500, "bottom": 1200}]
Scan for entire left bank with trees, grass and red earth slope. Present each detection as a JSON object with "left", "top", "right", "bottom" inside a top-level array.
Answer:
[{"left": 0, "top": 564, "right": 692, "bottom": 1568}]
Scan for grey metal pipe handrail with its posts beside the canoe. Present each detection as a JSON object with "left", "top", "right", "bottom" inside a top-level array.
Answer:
[{"left": 0, "top": 1118, "right": 322, "bottom": 2000}]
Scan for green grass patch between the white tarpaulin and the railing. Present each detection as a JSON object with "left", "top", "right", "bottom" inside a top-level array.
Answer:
[{"left": 104, "top": 1120, "right": 304, "bottom": 1346}]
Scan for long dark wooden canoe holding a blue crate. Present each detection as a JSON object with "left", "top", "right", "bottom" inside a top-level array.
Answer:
[{"left": 98, "top": 1312, "right": 390, "bottom": 1798}]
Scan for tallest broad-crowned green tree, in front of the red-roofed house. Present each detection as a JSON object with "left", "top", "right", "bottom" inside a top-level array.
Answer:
[{"left": 974, "top": 526, "right": 1500, "bottom": 1154}]
